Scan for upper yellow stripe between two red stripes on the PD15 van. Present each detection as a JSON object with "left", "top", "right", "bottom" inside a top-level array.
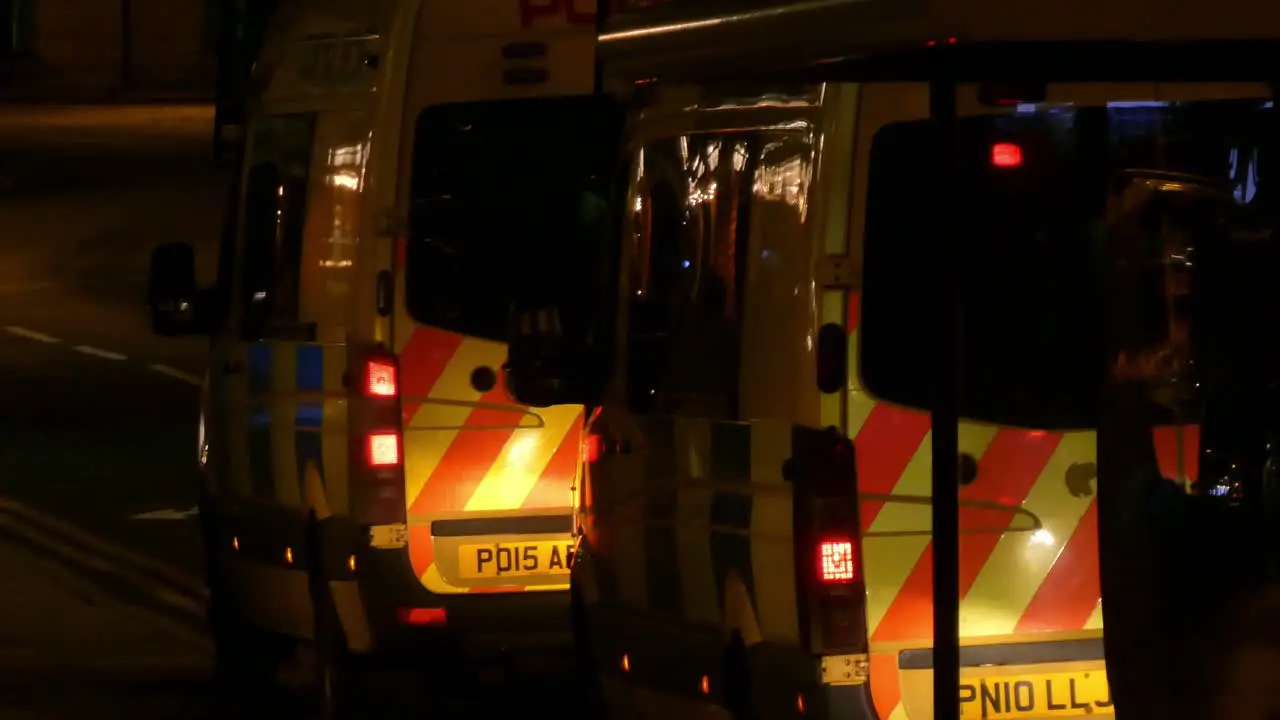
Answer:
[{"left": 404, "top": 340, "right": 506, "bottom": 506}]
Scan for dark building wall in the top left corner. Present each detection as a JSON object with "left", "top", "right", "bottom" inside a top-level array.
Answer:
[{"left": 0, "top": 0, "right": 220, "bottom": 101}]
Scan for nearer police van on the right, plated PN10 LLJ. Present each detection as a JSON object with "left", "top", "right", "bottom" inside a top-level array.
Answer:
[{"left": 496, "top": 0, "right": 1276, "bottom": 720}]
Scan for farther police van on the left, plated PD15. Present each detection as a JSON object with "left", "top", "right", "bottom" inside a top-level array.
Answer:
[{"left": 152, "top": 0, "right": 621, "bottom": 711}]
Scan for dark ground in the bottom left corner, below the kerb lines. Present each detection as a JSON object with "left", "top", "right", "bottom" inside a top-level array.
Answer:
[{"left": 0, "top": 512, "right": 210, "bottom": 720}]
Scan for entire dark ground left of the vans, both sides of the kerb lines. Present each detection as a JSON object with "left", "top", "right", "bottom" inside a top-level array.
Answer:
[{"left": 0, "top": 108, "right": 230, "bottom": 719}]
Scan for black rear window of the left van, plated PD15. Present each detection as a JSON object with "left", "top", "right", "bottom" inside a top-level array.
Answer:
[{"left": 406, "top": 96, "right": 622, "bottom": 340}]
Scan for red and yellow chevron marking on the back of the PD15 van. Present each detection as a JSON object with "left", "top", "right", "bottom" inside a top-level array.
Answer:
[{"left": 399, "top": 325, "right": 582, "bottom": 593}]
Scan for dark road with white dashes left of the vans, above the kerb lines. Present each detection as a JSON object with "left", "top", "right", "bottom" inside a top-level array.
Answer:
[{"left": 0, "top": 106, "right": 216, "bottom": 578}]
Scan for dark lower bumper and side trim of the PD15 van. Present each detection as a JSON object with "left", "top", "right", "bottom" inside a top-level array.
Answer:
[{"left": 201, "top": 506, "right": 572, "bottom": 664}]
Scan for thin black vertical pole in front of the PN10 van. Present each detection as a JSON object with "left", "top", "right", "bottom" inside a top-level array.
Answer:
[{"left": 929, "top": 63, "right": 961, "bottom": 720}]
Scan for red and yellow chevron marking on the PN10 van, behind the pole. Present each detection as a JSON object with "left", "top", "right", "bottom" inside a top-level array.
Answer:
[{"left": 849, "top": 296, "right": 1199, "bottom": 720}]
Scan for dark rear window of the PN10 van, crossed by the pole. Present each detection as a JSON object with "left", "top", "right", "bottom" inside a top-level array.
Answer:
[{"left": 860, "top": 100, "right": 1276, "bottom": 429}]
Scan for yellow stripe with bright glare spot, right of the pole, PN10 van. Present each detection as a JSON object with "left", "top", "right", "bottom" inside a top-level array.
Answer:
[{"left": 960, "top": 432, "right": 1097, "bottom": 637}]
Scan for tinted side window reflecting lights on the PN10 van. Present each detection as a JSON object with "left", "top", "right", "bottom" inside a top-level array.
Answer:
[{"left": 627, "top": 133, "right": 760, "bottom": 419}]
